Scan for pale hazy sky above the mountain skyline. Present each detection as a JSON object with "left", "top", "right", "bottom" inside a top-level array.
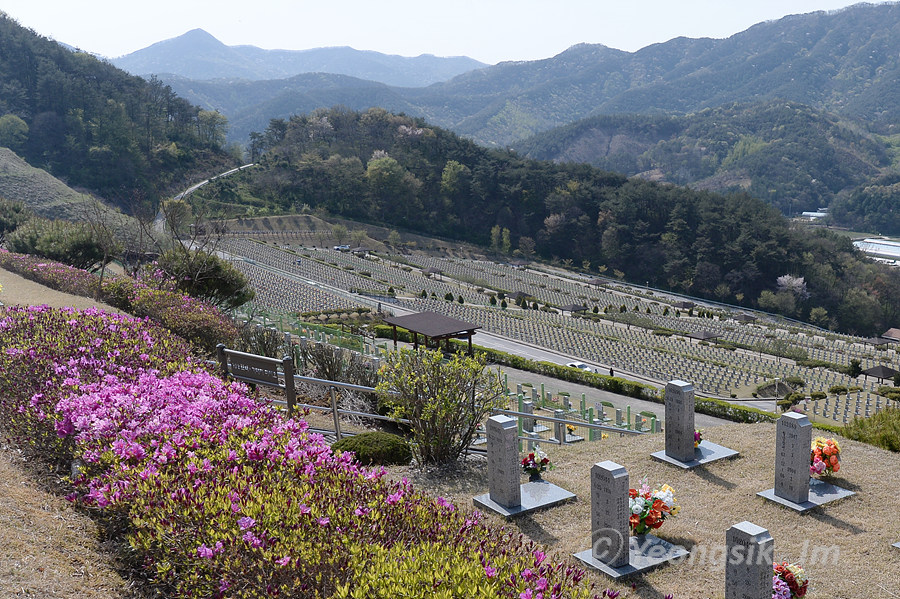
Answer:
[{"left": 0, "top": 0, "right": 884, "bottom": 63}]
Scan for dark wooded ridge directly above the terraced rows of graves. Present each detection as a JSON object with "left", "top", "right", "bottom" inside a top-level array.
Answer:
[{"left": 202, "top": 109, "right": 900, "bottom": 334}]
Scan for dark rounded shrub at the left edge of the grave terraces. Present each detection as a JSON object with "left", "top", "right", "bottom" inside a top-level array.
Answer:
[{"left": 158, "top": 245, "right": 256, "bottom": 310}]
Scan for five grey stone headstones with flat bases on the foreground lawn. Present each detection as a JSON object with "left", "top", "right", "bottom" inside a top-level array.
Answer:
[{"left": 473, "top": 381, "right": 868, "bottom": 599}]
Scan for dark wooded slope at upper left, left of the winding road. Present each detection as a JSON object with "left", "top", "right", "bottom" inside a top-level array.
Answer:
[{"left": 0, "top": 12, "right": 235, "bottom": 207}]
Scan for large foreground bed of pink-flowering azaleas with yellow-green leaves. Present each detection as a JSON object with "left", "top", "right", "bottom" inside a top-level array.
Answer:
[{"left": 0, "top": 307, "right": 604, "bottom": 599}]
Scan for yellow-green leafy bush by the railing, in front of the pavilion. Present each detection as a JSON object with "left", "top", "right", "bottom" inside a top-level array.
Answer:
[{"left": 377, "top": 349, "right": 505, "bottom": 464}]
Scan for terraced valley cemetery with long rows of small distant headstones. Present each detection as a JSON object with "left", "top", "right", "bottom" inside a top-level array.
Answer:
[{"left": 223, "top": 235, "right": 900, "bottom": 412}]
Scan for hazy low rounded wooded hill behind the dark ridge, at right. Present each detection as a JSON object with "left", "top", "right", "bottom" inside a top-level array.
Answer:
[{"left": 515, "top": 101, "right": 900, "bottom": 221}]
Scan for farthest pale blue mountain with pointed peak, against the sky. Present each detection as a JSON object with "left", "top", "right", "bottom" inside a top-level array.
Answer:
[{"left": 110, "top": 29, "right": 487, "bottom": 87}]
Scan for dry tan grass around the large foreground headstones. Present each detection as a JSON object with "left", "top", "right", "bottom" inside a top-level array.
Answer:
[{"left": 391, "top": 424, "right": 900, "bottom": 599}]
